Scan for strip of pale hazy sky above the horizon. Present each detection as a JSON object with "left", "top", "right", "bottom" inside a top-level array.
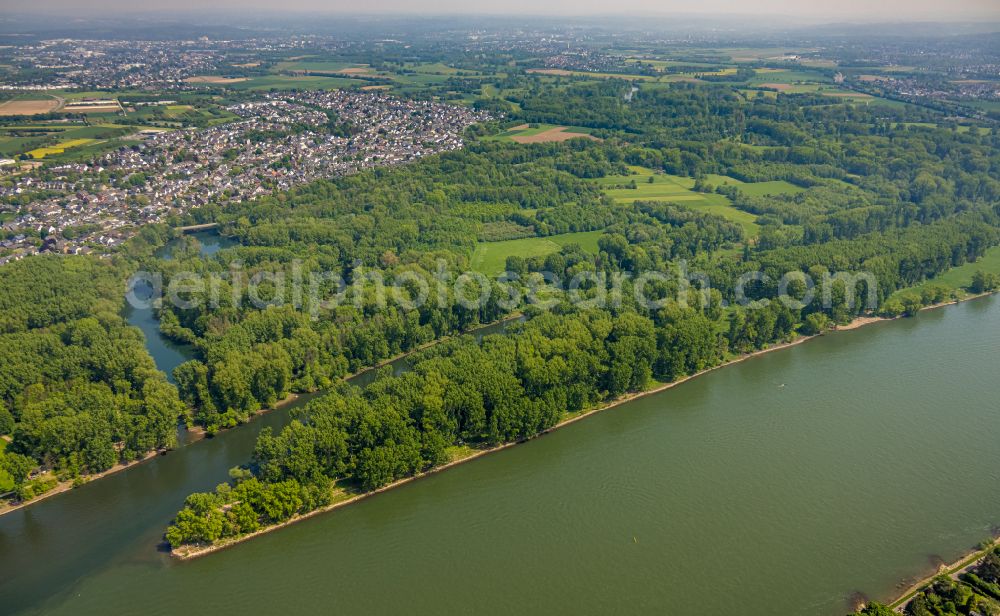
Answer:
[{"left": 11, "top": 0, "right": 1000, "bottom": 21}]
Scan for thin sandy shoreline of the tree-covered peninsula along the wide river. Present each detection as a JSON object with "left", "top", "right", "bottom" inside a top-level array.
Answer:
[{"left": 170, "top": 293, "right": 990, "bottom": 560}]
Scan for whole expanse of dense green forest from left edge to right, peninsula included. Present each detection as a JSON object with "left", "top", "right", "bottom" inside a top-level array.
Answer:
[{"left": 0, "top": 75, "right": 1000, "bottom": 524}]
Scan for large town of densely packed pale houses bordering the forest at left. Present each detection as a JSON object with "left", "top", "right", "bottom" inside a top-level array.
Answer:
[{"left": 0, "top": 91, "right": 489, "bottom": 264}]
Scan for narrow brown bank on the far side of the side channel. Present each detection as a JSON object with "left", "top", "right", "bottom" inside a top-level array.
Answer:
[{"left": 0, "top": 312, "right": 524, "bottom": 516}]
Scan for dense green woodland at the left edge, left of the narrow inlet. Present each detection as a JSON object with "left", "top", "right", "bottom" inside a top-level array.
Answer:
[{"left": 0, "top": 256, "right": 184, "bottom": 499}]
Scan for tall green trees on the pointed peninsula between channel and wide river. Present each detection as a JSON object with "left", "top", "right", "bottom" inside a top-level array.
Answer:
[{"left": 167, "top": 305, "right": 776, "bottom": 547}]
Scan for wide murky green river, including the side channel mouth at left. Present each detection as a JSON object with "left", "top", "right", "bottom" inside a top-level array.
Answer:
[{"left": 0, "top": 235, "right": 1000, "bottom": 616}]
